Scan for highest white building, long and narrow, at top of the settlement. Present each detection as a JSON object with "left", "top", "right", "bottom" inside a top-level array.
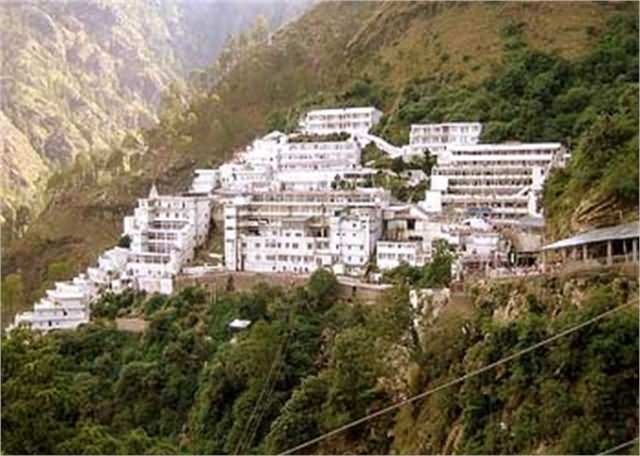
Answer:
[{"left": 300, "top": 106, "right": 382, "bottom": 135}]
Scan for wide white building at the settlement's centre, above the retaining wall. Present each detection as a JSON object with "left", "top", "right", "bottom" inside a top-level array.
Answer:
[{"left": 224, "top": 189, "right": 389, "bottom": 274}]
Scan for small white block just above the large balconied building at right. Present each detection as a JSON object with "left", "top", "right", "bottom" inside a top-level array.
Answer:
[{"left": 409, "top": 122, "right": 482, "bottom": 155}]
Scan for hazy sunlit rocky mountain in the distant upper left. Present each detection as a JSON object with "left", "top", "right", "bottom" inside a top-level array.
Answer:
[{"left": 0, "top": 0, "right": 305, "bottom": 234}]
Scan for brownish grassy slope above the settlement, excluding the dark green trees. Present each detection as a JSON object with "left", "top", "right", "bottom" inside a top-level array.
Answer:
[{"left": 3, "top": 3, "right": 636, "bottom": 318}]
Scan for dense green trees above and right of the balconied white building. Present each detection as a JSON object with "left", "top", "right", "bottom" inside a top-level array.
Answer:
[{"left": 377, "top": 16, "right": 639, "bottom": 236}]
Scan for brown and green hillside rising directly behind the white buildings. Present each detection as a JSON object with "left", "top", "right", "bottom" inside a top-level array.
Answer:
[{"left": 3, "top": 2, "right": 638, "bottom": 342}]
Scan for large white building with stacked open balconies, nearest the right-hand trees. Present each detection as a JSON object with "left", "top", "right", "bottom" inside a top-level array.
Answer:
[{"left": 422, "top": 143, "right": 568, "bottom": 224}]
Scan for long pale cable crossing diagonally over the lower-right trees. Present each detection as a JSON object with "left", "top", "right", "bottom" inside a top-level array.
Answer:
[{"left": 281, "top": 303, "right": 632, "bottom": 455}]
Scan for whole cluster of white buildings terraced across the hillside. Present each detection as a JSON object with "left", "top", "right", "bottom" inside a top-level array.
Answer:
[{"left": 12, "top": 107, "right": 638, "bottom": 331}]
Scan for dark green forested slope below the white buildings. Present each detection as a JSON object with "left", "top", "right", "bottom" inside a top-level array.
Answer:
[{"left": 2, "top": 271, "right": 639, "bottom": 454}]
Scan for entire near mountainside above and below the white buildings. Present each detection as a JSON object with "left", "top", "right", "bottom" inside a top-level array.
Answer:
[{"left": 2, "top": 2, "right": 638, "bottom": 454}]
